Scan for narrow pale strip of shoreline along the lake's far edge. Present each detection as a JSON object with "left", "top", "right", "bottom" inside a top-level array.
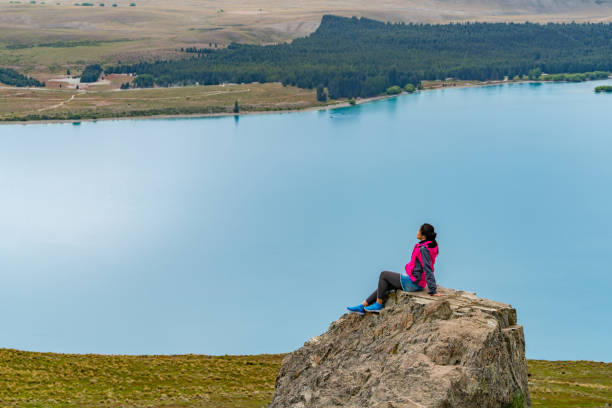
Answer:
[{"left": 0, "top": 81, "right": 516, "bottom": 125}]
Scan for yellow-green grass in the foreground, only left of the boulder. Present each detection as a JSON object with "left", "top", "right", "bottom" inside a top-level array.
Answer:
[{"left": 0, "top": 349, "right": 283, "bottom": 408}]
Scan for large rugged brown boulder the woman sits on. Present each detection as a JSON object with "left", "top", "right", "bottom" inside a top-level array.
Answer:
[{"left": 269, "top": 288, "right": 531, "bottom": 408}]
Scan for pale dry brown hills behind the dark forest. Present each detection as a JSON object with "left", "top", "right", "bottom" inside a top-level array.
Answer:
[{"left": 0, "top": 0, "right": 612, "bottom": 75}]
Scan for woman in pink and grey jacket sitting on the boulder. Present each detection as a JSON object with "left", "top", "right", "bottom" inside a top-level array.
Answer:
[{"left": 347, "top": 224, "right": 440, "bottom": 315}]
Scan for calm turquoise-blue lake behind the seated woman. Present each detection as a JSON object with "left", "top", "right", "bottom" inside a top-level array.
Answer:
[{"left": 0, "top": 81, "right": 612, "bottom": 361}]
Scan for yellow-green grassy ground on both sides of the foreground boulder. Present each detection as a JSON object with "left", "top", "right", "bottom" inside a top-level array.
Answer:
[{"left": 0, "top": 349, "right": 612, "bottom": 408}]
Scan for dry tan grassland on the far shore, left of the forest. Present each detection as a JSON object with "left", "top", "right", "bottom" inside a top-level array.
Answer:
[{"left": 0, "top": 83, "right": 334, "bottom": 122}]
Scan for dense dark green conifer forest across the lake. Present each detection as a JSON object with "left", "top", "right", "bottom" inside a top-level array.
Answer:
[{"left": 106, "top": 15, "right": 612, "bottom": 98}]
